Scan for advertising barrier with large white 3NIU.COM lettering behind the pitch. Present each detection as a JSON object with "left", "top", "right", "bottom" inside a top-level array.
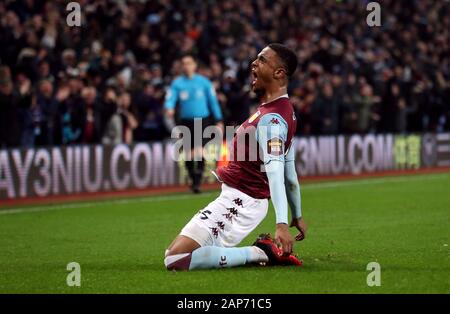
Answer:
[{"left": 0, "top": 133, "right": 450, "bottom": 200}]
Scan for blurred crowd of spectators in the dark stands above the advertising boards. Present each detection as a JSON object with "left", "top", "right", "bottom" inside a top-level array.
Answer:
[{"left": 0, "top": 0, "right": 450, "bottom": 147}]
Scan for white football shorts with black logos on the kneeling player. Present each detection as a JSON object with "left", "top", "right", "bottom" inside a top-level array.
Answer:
[{"left": 180, "top": 183, "right": 269, "bottom": 247}]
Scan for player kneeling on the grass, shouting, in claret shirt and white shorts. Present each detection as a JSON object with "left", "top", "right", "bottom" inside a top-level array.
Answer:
[{"left": 164, "top": 44, "right": 307, "bottom": 270}]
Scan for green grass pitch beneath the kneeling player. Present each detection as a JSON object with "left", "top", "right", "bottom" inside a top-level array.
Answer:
[{"left": 0, "top": 174, "right": 450, "bottom": 294}]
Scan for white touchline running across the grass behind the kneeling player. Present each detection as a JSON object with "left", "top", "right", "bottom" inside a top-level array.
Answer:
[{"left": 0, "top": 173, "right": 449, "bottom": 215}]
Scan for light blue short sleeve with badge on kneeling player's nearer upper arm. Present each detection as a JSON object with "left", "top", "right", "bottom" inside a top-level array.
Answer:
[{"left": 256, "top": 113, "right": 288, "bottom": 164}]
